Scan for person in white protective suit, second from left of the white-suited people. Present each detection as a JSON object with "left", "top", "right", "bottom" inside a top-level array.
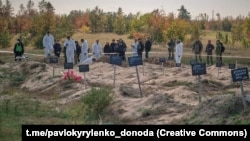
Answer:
[{"left": 64, "top": 36, "right": 76, "bottom": 64}]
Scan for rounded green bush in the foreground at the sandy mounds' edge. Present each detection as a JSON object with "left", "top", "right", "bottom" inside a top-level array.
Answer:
[{"left": 82, "top": 88, "right": 113, "bottom": 121}]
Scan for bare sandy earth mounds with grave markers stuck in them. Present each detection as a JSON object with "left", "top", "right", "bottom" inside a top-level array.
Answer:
[{"left": 4, "top": 55, "right": 249, "bottom": 124}]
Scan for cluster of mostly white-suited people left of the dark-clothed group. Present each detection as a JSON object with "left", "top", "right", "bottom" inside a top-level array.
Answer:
[{"left": 43, "top": 31, "right": 102, "bottom": 64}]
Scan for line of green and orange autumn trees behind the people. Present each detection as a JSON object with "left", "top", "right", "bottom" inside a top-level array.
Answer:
[{"left": 0, "top": 0, "right": 250, "bottom": 48}]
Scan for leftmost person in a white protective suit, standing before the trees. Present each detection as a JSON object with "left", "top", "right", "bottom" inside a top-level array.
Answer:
[{"left": 43, "top": 31, "right": 54, "bottom": 58}]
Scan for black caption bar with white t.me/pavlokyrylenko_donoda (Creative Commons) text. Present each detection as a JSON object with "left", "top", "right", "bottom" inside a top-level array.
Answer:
[{"left": 22, "top": 125, "right": 250, "bottom": 141}]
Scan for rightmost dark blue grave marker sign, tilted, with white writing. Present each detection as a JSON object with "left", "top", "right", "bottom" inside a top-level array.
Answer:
[{"left": 231, "top": 68, "right": 249, "bottom": 82}]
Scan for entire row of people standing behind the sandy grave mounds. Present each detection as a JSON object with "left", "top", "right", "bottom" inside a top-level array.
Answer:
[{"left": 13, "top": 31, "right": 223, "bottom": 65}]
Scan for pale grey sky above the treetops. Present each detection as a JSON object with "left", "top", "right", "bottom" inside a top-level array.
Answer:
[{"left": 9, "top": 0, "right": 250, "bottom": 19}]
